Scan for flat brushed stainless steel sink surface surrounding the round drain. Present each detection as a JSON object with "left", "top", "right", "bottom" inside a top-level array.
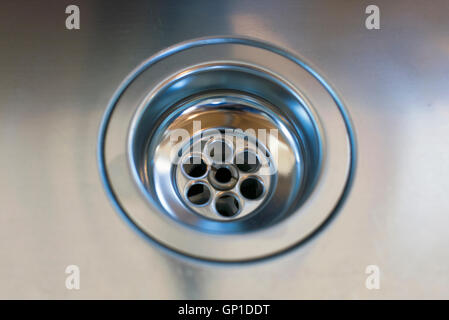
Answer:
[{"left": 0, "top": 0, "right": 449, "bottom": 299}]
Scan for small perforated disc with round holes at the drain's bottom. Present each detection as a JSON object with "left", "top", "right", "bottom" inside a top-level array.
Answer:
[{"left": 175, "top": 125, "right": 276, "bottom": 221}]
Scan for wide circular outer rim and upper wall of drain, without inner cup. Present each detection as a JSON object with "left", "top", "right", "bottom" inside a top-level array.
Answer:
[{"left": 98, "top": 38, "right": 355, "bottom": 262}]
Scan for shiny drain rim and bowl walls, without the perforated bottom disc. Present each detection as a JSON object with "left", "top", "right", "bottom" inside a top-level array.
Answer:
[{"left": 103, "top": 37, "right": 355, "bottom": 262}]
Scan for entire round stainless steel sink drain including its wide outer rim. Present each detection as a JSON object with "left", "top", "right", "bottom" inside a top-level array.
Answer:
[{"left": 99, "top": 38, "right": 354, "bottom": 261}]
